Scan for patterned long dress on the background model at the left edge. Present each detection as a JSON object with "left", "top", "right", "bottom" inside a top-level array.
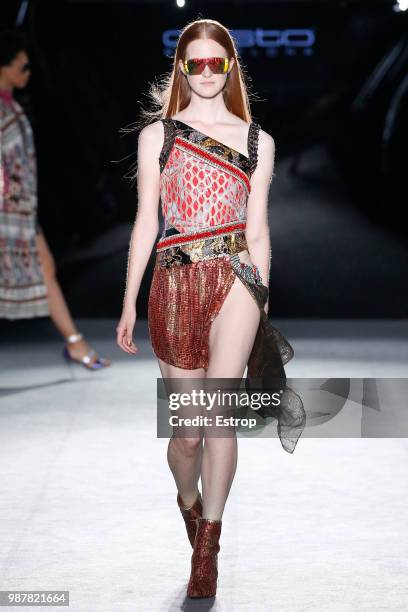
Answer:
[{"left": 0, "top": 90, "right": 49, "bottom": 320}]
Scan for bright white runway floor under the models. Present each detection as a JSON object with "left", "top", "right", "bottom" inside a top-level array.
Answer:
[{"left": 0, "top": 320, "right": 408, "bottom": 612}]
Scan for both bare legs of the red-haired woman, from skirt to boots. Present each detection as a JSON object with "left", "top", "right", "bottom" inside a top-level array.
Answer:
[{"left": 158, "top": 252, "right": 260, "bottom": 519}]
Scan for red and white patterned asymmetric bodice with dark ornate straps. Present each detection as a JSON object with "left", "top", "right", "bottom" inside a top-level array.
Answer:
[{"left": 159, "top": 118, "right": 260, "bottom": 233}]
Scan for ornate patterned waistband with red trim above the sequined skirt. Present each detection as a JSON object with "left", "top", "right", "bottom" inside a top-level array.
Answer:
[{"left": 157, "top": 223, "right": 248, "bottom": 267}]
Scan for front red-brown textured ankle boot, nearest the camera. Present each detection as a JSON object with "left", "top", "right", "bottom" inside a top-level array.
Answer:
[{"left": 187, "top": 517, "right": 222, "bottom": 597}]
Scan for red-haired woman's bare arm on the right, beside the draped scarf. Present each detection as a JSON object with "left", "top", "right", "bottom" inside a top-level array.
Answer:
[{"left": 245, "top": 130, "right": 275, "bottom": 310}]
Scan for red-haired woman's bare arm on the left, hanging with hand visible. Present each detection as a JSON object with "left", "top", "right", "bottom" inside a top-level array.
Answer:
[{"left": 117, "top": 121, "right": 164, "bottom": 353}]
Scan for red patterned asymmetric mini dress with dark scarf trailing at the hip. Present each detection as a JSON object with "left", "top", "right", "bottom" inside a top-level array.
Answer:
[{"left": 148, "top": 118, "right": 305, "bottom": 452}]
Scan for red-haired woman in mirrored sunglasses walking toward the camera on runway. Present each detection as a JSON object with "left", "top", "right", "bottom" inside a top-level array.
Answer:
[{"left": 117, "top": 19, "right": 306, "bottom": 598}]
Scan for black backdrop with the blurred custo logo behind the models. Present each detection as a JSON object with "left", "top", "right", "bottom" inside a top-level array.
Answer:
[{"left": 2, "top": 1, "right": 408, "bottom": 318}]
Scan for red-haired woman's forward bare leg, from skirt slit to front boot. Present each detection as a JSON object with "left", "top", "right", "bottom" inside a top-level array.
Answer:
[{"left": 201, "top": 258, "right": 260, "bottom": 520}]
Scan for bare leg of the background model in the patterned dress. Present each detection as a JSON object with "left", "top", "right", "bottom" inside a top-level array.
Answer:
[{"left": 36, "top": 232, "right": 110, "bottom": 363}]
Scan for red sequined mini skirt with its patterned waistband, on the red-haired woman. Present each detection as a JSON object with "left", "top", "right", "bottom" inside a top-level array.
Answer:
[{"left": 148, "top": 223, "right": 268, "bottom": 370}]
